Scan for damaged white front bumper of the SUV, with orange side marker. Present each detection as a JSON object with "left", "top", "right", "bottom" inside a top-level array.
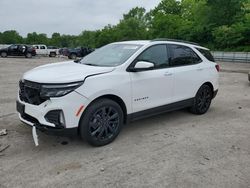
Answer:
[{"left": 17, "top": 92, "right": 88, "bottom": 136}]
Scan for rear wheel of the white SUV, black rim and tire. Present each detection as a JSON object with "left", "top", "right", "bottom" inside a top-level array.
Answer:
[{"left": 190, "top": 85, "right": 213, "bottom": 115}]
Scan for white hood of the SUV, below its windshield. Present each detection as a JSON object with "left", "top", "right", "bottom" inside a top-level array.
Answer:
[{"left": 22, "top": 61, "right": 115, "bottom": 83}]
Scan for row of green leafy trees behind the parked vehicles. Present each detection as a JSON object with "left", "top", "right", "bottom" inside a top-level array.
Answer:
[{"left": 0, "top": 0, "right": 250, "bottom": 51}]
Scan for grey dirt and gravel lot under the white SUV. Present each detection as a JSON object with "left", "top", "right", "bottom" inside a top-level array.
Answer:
[{"left": 0, "top": 58, "right": 250, "bottom": 188}]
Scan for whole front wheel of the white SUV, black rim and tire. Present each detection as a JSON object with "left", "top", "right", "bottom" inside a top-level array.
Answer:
[{"left": 79, "top": 99, "right": 124, "bottom": 146}]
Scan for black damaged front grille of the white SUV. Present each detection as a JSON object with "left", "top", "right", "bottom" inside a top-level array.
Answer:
[{"left": 19, "top": 80, "right": 46, "bottom": 105}]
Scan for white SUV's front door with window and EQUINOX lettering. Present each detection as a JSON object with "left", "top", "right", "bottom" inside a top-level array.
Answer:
[{"left": 130, "top": 44, "right": 173, "bottom": 112}]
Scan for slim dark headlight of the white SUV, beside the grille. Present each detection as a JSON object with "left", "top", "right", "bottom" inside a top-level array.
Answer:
[{"left": 40, "top": 82, "right": 83, "bottom": 98}]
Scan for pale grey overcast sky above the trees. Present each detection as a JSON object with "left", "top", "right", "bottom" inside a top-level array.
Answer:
[{"left": 0, "top": 0, "right": 160, "bottom": 36}]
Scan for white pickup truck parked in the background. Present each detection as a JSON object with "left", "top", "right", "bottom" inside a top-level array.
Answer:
[{"left": 33, "top": 44, "right": 59, "bottom": 57}]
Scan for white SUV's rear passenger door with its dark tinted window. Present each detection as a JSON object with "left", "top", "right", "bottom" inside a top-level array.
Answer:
[{"left": 168, "top": 44, "right": 206, "bottom": 102}]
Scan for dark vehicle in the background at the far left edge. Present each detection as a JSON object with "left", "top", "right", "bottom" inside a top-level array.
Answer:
[{"left": 0, "top": 44, "right": 36, "bottom": 58}]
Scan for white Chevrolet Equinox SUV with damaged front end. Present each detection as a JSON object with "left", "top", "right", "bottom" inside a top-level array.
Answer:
[{"left": 17, "top": 39, "right": 219, "bottom": 146}]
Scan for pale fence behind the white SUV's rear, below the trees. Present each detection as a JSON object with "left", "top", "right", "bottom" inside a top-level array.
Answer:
[{"left": 212, "top": 52, "right": 250, "bottom": 63}]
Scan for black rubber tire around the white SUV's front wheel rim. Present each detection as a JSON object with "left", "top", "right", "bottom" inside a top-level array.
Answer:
[{"left": 79, "top": 99, "right": 124, "bottom": 146}]
